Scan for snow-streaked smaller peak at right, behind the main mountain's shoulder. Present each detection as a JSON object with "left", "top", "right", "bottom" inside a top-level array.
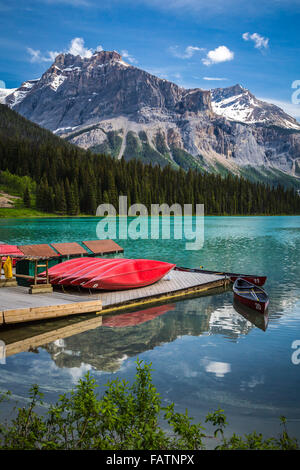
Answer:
[{"left": 211, "top": 85, "right": 300, "bottom": 130}]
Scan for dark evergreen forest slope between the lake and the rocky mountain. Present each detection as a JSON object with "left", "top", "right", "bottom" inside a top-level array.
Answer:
[{"left": 0, "top": 105, "right": 300, "bottom": 215}]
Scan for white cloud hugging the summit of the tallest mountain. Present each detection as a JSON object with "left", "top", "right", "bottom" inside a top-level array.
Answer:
[{"left": 27, "top": 38, "right": 103, "bottom": 62}]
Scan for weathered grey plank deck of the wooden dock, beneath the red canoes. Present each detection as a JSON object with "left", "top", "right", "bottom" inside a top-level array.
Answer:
[{"left": 0, "top": 270, "right": 228, "bottom": 326}]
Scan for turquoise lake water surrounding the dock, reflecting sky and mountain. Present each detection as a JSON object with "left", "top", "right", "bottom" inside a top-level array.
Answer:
[{"left": 0, "top": 217, "right": 300, "bottom": 439}]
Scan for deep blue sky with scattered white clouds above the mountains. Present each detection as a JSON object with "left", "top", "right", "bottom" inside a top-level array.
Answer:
[{"left": 0, "top": 0, "right": 300, "bottom": 118}]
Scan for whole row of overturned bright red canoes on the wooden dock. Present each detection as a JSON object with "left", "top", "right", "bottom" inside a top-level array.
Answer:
[{"left": 39, "top": 258, "right": 175, "bottom": 290}]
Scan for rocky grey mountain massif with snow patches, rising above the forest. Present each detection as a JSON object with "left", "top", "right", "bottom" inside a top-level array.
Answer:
[{"left": 4, "top": 51, "right": 300, "bottom": 181}]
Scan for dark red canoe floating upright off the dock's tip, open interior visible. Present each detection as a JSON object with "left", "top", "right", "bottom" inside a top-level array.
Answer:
[{"left": 233, "top": 278, "right": 269, "bottom": 313}]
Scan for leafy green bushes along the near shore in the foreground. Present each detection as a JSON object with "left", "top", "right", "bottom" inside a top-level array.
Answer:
[{"left": 0, "top": 360, "right": 299, "bottom": 450}]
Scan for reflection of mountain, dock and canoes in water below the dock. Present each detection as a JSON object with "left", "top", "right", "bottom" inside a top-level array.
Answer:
[{"left": 1, "top": 291, "right": 268, "bottom": 372}]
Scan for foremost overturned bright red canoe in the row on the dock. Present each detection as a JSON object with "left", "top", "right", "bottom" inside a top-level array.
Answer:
[{"left": 81, "top": 259, "right": 176, "bottom": 290}]
